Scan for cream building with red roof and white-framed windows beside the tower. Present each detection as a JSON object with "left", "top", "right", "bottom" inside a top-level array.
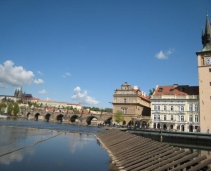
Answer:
[{"left": 151, "top": 84, "right": 200, "bottom": 132}]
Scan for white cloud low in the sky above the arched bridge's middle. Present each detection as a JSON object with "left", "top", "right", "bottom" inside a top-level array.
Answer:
[{"left": 71, "top": 87, "right": 99, "bottom": 105}]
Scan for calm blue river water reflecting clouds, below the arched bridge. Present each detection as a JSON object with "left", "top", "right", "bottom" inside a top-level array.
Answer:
[{"left": 0, "top": 118, "right": 116, "bottom": 171}]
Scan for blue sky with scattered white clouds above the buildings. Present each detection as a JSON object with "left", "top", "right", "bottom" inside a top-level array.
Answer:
[{"left": 0, "top": 0, "right": 211, "bottom": 108}]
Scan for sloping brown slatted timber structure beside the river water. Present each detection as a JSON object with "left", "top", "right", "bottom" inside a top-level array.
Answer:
[{"left": 95, "top": 129, "right": 211, "bottom": 171}]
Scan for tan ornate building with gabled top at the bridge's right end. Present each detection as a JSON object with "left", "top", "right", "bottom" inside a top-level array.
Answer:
[{"left": 112, "top": 82, "right": 150, "bottom": 127}]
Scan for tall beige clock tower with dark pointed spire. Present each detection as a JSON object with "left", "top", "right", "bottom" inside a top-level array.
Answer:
[{"left": 196, "top": 14, "right": 211, "bottom": 133}]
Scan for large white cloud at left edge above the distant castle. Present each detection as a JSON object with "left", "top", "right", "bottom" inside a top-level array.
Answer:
[{"left": 0, "top": 60, "right": 34, "bottom": 86}]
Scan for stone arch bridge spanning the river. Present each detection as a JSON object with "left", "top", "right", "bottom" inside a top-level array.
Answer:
[{"left": 22, "top": 110, "right": 113, "bottom": 125}]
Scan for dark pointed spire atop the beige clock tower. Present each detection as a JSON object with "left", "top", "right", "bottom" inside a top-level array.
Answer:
[{"left": 202, "top": 13, "right": 211, "bottom": 51}]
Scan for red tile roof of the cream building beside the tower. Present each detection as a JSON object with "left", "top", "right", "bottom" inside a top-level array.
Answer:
[{"left": 153, "top": 85, "right": 199, "bottom": 95}]
